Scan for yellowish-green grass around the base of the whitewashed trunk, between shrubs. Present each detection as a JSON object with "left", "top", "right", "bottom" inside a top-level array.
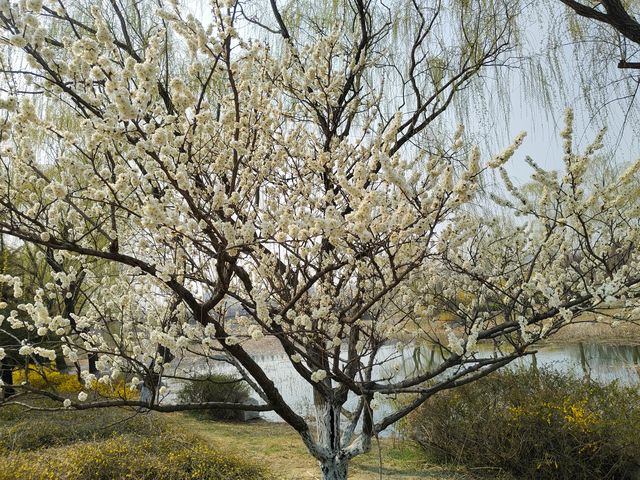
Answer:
[{"left": 167, "top": 413, "right": 504, "bottom": 480}]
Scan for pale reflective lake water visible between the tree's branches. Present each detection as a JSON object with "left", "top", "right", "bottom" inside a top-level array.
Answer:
[{"left": 166, "top": 343, "right": 640, "bottom": 430}]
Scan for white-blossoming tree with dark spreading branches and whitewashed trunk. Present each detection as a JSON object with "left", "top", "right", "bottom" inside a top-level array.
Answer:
[{"left": 0, "top": 0, "right": 640, "bottom": 479}]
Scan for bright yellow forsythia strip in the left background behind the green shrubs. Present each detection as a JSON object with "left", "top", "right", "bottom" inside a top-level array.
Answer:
[{"left": 13, "top": 367, "right": 140, "bottom": 399}]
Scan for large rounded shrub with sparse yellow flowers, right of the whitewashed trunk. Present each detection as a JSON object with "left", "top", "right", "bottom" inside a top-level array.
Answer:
[{"left": 404, "top": 368, "right": 640, "bottom": 480}]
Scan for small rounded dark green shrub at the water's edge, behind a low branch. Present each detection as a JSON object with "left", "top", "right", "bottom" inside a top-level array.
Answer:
[{"left": 178, "top": 374, "right": 250, "bottom": 420}]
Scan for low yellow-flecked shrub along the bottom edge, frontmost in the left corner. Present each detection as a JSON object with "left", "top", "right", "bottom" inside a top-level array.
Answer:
[{"left": 0, "top": 435, "right": 270, "bottom": 480}]
